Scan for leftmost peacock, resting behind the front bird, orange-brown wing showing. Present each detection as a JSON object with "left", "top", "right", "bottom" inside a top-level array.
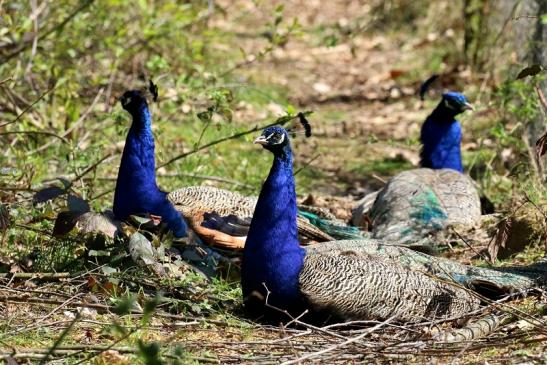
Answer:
[{"left": 114, "top": 90, "right": 361, "bottom": 249}]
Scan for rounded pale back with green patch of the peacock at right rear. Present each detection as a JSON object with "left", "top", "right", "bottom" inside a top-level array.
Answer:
[{"left": 369, "top": 168, "right": 481, "bottom": 243}]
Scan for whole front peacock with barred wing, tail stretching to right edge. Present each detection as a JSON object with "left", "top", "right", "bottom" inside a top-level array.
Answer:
[{"left": 241, "top": 126, "right": 547, "bottom": 322}]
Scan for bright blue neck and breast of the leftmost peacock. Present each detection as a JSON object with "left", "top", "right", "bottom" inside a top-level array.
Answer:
[{"left": 114, "top": 105, "right": 186, "bottom": 237}]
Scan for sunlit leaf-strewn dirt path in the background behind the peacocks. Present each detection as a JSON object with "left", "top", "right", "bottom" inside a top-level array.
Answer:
[{"left": 214, "top": 1, "right": 454, "bottom": 198}]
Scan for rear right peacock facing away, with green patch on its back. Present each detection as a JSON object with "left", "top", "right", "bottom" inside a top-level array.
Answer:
[{"left": 352, "top": 92, "right": 481, "bottom": 243}]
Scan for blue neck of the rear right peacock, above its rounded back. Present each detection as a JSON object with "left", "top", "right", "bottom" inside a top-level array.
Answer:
[{"left": 420, "top": 101, "right": 463, "bottom": 172}]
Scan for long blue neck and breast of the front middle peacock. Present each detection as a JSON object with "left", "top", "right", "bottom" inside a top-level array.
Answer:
[{"left": 241, "top": 146, "right": 304, "bottom": 308}]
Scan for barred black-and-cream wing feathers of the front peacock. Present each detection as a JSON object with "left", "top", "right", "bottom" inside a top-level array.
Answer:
[{"left": 299, "top": 252, "right": 479, "bottom": 322}]
